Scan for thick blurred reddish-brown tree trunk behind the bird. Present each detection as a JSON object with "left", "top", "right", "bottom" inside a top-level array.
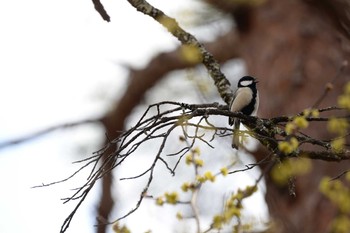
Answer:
[{"left": 228, "top": 0, "right": 350, "bottom": 233}]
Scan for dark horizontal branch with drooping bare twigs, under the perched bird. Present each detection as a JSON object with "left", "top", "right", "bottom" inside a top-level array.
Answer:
[{"left": 33, "top": 101, "right": 350, "bottom": 232}]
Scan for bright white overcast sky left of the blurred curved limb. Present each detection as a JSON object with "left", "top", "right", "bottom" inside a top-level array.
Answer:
[{"left": 0, "top": 0, "right": 266, "bottom": 233}]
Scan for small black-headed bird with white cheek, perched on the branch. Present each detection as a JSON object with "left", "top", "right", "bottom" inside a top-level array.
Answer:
[{"left": 229, "top": 76, "right": 259, "bottom": 149}]
